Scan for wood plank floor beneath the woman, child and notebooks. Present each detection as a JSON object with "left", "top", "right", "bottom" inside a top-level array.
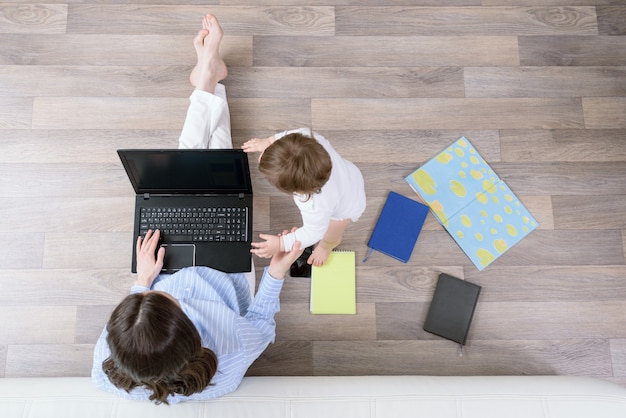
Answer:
[{"left": 0, "top": 0, "right": 626, "bottom": 385}]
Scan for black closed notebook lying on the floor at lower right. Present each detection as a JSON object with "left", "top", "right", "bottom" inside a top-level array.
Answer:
[{"left": 424, "top": 273, "right": 481, "bottom": 345}]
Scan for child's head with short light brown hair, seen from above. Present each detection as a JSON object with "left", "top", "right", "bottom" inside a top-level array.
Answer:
[{"left": 259, "top": 133, "right": 333, "bottom": 196}]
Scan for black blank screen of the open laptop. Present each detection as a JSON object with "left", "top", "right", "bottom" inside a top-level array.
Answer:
[{"left": 118, "top": 149, "right": 252, "bottom": 194}]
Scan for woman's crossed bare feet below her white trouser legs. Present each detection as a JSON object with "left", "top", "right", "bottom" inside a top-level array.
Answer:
[{"left": 190, "top": 14, "right": 228, "bottom": 93}]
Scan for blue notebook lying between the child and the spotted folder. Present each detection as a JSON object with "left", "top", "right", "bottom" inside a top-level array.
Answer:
[{"left": 367, "top": 192, "right": 429, "bottom": 263}]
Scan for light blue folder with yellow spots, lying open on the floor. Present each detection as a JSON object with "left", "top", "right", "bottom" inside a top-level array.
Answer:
[{"left": 405, "top": 137, "right": 538, "bottom": 270}]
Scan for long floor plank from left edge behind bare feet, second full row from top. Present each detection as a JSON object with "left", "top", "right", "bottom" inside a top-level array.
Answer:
[{"left": 0, "top": 34, "right": 252, "bottom": 66}]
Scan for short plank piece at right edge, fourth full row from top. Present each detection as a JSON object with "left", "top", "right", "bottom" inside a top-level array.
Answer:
[{"left": 583, "top": 97, "right": 626, "bottom": 129}]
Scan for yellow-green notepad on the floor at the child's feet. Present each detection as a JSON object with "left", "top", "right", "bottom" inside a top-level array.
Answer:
[{"left": 311, "top": 251, "right": 356, "bottom": 314}]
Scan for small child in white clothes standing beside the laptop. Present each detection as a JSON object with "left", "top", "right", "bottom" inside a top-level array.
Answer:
[{"left": 242, "top": 128, "right": 365, "bottom": 266}]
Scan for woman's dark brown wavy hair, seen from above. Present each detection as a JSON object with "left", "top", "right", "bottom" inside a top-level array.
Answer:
[{"left": 102, "top": 292, "right": 217, "bottom": 404}]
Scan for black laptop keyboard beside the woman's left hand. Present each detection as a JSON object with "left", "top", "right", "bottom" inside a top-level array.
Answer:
[{"left": 139, "top": 207, "right": 248, "bottom": 242}]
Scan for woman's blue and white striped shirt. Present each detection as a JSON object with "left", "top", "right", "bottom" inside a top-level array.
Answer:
[{"left": 91, "top": 267, "right": 283, "bottom": 404}]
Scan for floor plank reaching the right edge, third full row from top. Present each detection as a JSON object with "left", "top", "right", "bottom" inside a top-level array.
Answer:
[{"left": 464, "top": 67, "right": 626, "bottom": 97}]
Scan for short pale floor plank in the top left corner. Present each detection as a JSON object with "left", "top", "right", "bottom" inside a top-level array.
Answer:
[{"left": 0, "top": 2, "right": 68, "bottom": 35}]
